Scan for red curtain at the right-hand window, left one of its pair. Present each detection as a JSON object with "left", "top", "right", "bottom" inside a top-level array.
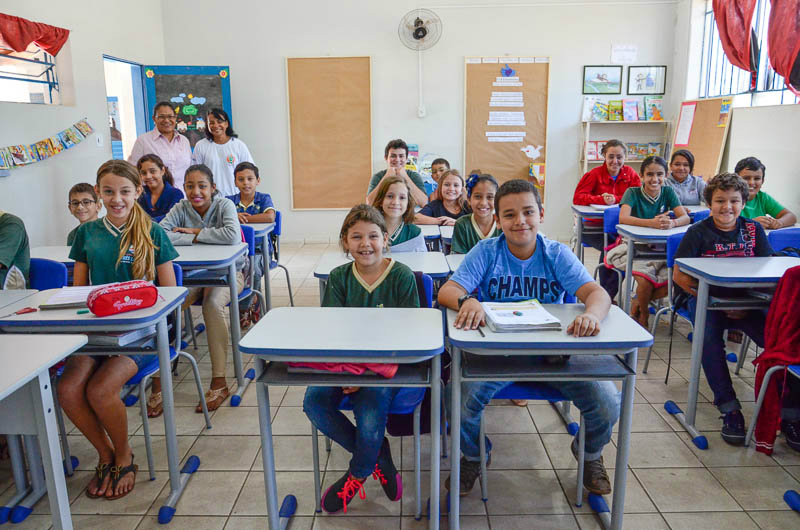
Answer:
[{"left": 713, "top": 0, "right": 756, "bottom": 72}]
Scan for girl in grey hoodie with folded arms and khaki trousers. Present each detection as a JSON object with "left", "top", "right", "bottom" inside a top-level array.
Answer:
[{"left": 160, "top": 164, "right": 247, "bottom": 410}]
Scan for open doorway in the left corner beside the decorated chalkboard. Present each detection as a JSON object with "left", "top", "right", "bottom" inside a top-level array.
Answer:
[{"left": 103, "top": 55, "right": 147, "bottom": 160}]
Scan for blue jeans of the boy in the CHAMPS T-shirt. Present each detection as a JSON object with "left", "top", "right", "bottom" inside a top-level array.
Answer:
[{"left": 447, "top": 381, "right": 621, "bottom": 462}]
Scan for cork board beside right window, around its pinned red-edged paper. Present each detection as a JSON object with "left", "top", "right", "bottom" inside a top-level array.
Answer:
[{"left": 672, "top": 98, "right": 731, "bottom": 180}]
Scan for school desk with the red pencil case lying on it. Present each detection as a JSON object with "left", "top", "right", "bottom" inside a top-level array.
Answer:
[{"left": 0, "top": 287, "right": 198, "bottom": 522}]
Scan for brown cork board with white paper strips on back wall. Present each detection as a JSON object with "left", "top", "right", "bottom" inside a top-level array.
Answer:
[{"left": 464, "top": 56, "right": 550, "bottom": 202}]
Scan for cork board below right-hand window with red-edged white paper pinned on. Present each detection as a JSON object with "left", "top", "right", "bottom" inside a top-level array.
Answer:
[{"left": 672, "top": 98, "right": 731, "bottom": 180}]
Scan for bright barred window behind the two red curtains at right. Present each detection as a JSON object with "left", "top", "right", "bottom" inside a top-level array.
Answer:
[{"left": 699, "top": 0, "right": 800, "bottom": 107}]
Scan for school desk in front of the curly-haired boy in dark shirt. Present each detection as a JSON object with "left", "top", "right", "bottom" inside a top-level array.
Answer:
[{"left": 664, "top": 256, "right": 800, "bottom": 449}]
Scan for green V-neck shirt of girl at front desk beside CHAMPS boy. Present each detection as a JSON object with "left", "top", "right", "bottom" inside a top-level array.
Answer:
[{"left": 322, "top": 260, "right": 419, "bottom": 307}]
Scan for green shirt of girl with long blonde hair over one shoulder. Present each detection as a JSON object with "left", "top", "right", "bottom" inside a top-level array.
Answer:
[{"left": 69, "top": 217, "right": 178, "bottom": 285}]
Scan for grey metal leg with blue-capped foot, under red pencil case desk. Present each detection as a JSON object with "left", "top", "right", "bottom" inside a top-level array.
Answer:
[{"left": 156, "top": 316, "right": 199, "bottom": 524}]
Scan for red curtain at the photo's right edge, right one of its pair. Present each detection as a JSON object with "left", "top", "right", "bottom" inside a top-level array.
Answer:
[{"left": 767, "top": 0, "right": 800, "bottom": 96}]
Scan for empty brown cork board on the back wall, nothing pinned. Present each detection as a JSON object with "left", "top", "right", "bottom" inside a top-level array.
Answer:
[{"left": 286, "top": 57, "right": 372, "bottom": 210}]
